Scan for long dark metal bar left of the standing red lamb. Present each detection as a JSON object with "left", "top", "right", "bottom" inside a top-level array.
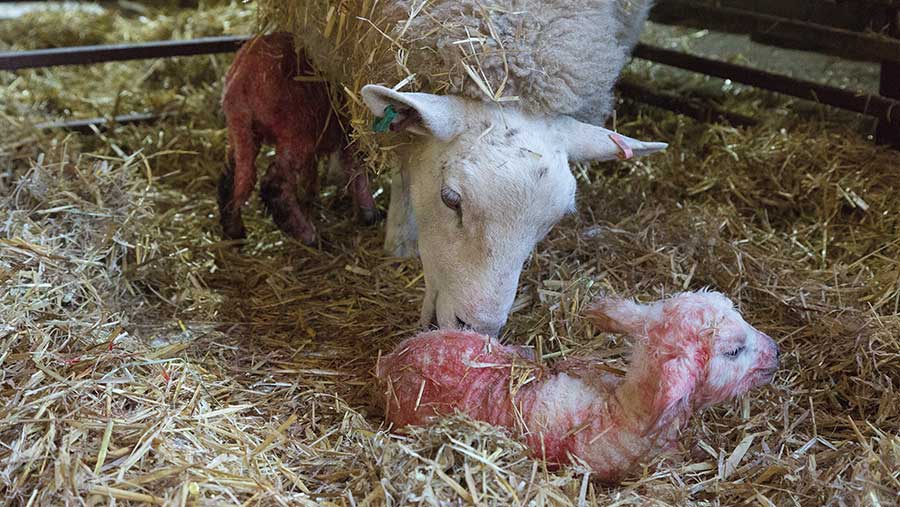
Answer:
[{"left": 0, "top": 36, "right": 249, "bottom": 70}]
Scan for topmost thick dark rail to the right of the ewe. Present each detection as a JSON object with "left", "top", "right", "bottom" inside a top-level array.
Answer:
[{"left": 651, "top": 0, "right": 900, "bottom": 62}]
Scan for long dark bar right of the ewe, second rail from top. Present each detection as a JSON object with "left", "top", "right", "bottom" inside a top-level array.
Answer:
[{"left": 634, "top": 44, "right": 900, "bottom": 126}]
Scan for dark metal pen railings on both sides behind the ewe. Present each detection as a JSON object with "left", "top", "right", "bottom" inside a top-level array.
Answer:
[{"left": 0, "top": 0, "right": 900, "bottom": 146}]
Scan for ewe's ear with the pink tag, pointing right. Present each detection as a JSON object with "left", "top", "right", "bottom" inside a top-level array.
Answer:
[{"left": 558, "top": 116, "right": 668, "bottom": 162}]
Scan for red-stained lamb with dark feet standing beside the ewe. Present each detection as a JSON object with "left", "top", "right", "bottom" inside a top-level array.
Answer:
[{"left": 219, "top": 33, "right": 378, "bottom": 244}]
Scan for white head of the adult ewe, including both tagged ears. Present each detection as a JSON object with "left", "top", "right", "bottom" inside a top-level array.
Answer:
[{"left": 361, "top": 85, "right": 666, "bottom": 336}]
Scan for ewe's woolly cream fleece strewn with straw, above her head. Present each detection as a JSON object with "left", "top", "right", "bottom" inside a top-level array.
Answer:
[{"left": 260, "top": 0, "right": 651, "bottom": 149}]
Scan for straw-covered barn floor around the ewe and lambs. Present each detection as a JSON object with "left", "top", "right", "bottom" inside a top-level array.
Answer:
[{"left": 0, "top": 3, "right": 900, "bottom": 506}]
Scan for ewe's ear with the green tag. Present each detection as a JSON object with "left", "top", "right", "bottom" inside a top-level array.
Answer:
[{"left": 362, "top": 85, "right": 464, "bottom": 141}]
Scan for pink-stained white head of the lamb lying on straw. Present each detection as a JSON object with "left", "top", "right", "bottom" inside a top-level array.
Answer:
[{"left": 588, "top": 292, "right": 779, "bottom": 431}]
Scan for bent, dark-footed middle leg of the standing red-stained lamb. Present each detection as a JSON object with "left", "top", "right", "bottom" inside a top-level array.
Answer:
[{"left": 260, "top": 147, "right": 316, "bottom": 246}]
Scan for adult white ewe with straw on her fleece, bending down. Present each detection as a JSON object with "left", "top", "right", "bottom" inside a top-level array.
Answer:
[{"left": 260, "top": 0, "right": 666, "bottom": 335}]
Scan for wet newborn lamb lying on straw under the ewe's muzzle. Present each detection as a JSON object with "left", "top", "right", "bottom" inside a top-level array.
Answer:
[{"left": 376, "top": 292, "right": 779, "bottom": 483}]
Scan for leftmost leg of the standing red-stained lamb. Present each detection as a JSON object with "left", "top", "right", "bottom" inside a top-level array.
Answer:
[{"left": 219, "top": 118, "right": 259, "bottom": 239}]
